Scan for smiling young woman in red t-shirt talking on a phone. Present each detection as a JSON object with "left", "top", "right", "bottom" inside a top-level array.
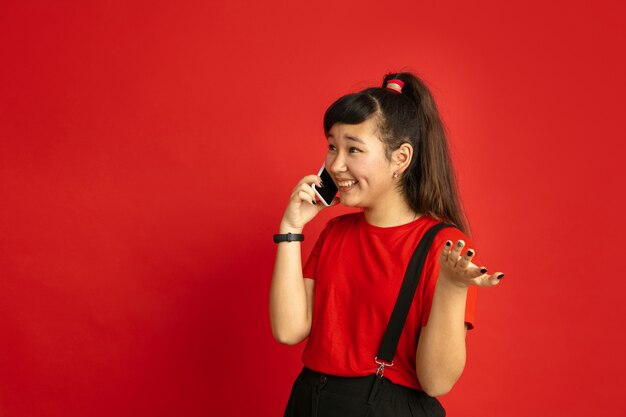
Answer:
[{"left": 270, "top": 73, "right": 504, "bottom": 417}]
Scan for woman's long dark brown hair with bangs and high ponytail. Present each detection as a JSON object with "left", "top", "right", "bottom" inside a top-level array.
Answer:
[{"left": 324, "top": 72, "right": 469, "bottom": 234}]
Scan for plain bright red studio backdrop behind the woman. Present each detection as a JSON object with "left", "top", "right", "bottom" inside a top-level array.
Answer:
[{"left": 0, "top": 0, "right": 626, "bottom": 417}]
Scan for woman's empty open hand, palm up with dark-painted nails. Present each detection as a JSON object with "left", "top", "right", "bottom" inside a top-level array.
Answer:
[{"left": 439, "top": 240, "right": 504, "bottom": 287}]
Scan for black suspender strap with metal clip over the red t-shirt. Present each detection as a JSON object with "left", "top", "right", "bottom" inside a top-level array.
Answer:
[{"left": 375, "top": 223, "right": 452, "bottom": 366}]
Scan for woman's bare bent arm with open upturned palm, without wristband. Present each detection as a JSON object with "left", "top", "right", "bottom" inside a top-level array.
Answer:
[{"left": 416, "top": 241, "right": 501, "bottom": 397}]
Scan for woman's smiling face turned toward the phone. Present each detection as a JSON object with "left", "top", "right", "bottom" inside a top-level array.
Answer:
[{"left": 326, "top": 117, "right": 397, "bottom": 209}]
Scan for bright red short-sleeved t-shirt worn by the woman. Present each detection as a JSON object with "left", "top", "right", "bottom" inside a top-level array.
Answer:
[{"left": 302, "top": 212, "right": 476, "bottom": 389}]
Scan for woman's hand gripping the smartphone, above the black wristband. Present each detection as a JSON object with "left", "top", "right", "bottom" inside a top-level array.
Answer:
[{"left": 280, "top": 175, "right": 339, "bottom": 233}]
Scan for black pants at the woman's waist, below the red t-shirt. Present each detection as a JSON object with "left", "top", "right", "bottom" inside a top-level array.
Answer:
[{"left": 284, "top": 368, "right": 446, "bottom": 417}]
